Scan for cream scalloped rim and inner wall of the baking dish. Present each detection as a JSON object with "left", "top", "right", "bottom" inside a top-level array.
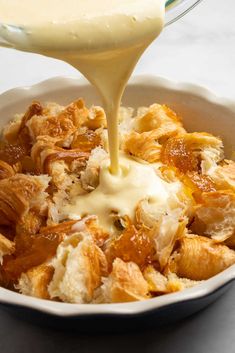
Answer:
[{"left": 0, "top": 76, "right": 235, "bottom": 326}]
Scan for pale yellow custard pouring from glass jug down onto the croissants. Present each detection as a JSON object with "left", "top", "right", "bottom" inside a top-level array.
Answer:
[{"left": 0, "top": 0, "right": 165, "bottom": 232}]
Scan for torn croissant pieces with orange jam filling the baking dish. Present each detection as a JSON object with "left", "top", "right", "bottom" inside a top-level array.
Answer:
[{"left": 0, "top": 99, "right": 235, "bottom": 303}]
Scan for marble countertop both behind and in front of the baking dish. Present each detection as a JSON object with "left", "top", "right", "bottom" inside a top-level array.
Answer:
[{"left": 0, "top": 0, "right": 235, "bottom": 353}]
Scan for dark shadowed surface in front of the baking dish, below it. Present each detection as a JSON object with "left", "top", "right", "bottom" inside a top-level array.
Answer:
[{"left": 0, "top": 286, "right": 235, "bottom": 353}]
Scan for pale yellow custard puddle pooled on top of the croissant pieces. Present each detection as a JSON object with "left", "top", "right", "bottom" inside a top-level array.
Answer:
[{"left": 63, "top": 154, "right": 181, "bottom": 233}]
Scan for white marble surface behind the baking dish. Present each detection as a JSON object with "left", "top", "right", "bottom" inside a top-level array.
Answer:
[{"left": 0, "top": 0, "right": 235, "bottom": 98}]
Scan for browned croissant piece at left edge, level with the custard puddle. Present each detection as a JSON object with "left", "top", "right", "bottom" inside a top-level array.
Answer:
[{"left": 0, "top": 174, "right": 50, "bottom": 225}]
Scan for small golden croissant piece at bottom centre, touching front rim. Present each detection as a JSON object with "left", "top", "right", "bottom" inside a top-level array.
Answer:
[{"left": 98, "top": 258, "right": 149, "bottom": 303}]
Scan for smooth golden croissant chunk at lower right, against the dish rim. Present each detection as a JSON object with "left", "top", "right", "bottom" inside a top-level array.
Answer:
[{"left": 167, "top": 235, "right": 235, "bottom": 281}]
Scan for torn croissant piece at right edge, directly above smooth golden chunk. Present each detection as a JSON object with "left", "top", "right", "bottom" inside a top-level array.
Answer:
[{"left": 192, "top": 191, "right": 235, "bottom": 242}]
